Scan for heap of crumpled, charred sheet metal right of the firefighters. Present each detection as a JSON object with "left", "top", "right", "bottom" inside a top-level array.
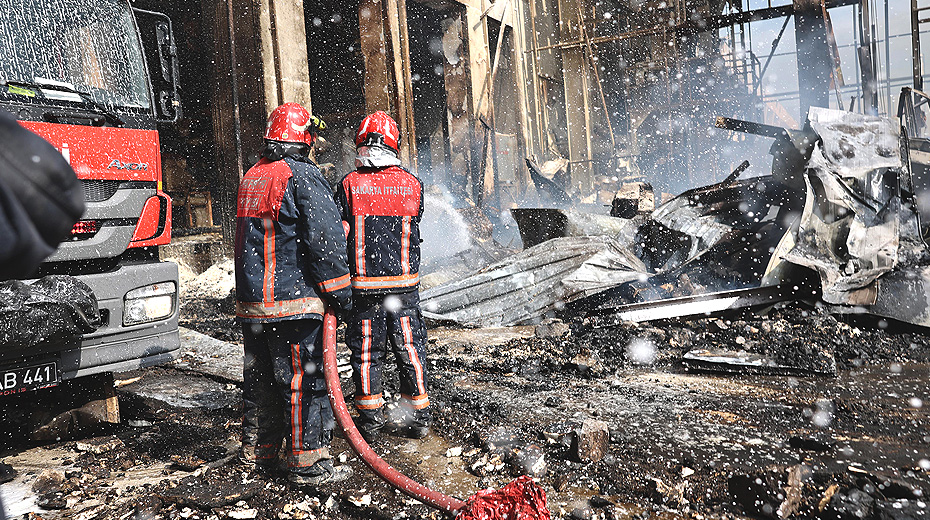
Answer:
[{"left": 423, "top": 108, "right": 930, "bottom": 334}]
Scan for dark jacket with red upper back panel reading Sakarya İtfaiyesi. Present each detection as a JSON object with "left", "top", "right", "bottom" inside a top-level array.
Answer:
[{"left": 336, "top": 166, "right": 423, "bottom": 295}]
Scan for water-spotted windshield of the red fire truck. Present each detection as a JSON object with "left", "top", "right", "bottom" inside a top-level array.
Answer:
[{"left": 0, "top": 0, "right": 151, "bottom": 109}]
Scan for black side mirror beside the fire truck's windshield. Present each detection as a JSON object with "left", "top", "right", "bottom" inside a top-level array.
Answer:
[{"left": 133, "top": 8, "right": 181, "bottom": 123}]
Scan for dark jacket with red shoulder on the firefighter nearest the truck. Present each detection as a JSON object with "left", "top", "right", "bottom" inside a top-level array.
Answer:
[{"left": 235, "top": 154, "right": 352, "bottom": 322}]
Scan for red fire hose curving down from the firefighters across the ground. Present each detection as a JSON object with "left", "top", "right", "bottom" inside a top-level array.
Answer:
[{"left": 323, "top": 310, "right": 550, "bottom": 520}]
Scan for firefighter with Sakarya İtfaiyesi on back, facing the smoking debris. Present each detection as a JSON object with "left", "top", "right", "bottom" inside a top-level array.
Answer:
[{"left": 336, "top": 111, "right": 431, "bottom": 442}]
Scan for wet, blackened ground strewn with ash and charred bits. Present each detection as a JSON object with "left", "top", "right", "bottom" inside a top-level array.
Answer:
[{"left": 3, "top": 260, "right": 930, "bottom": 520}]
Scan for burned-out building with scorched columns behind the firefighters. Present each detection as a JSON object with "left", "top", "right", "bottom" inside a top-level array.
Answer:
[{"left": 141, "top": 0, "right": 919, "bottom": 244}]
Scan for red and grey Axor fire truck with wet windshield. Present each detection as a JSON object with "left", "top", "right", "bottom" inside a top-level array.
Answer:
[{"left": 0, "top": 0, "right": 180, "bottom": 395}]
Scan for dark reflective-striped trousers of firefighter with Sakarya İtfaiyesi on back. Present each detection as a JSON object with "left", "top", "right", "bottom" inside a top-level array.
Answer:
[{"left": 346, "top": 290, "right": 432, "bottom": 433}]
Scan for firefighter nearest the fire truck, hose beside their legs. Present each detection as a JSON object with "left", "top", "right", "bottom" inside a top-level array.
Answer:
[{"left": 235, "top": 103, "right": 352, "bottom": 486}]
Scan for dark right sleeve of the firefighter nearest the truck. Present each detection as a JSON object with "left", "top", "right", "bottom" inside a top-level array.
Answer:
[{"left": 288, "top": 160, "right": 352, "bottom": 314}]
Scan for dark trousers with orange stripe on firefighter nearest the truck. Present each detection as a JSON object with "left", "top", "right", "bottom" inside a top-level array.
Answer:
[{"left": 242, "top": 319, "right": 335, "bottom": 471}]
